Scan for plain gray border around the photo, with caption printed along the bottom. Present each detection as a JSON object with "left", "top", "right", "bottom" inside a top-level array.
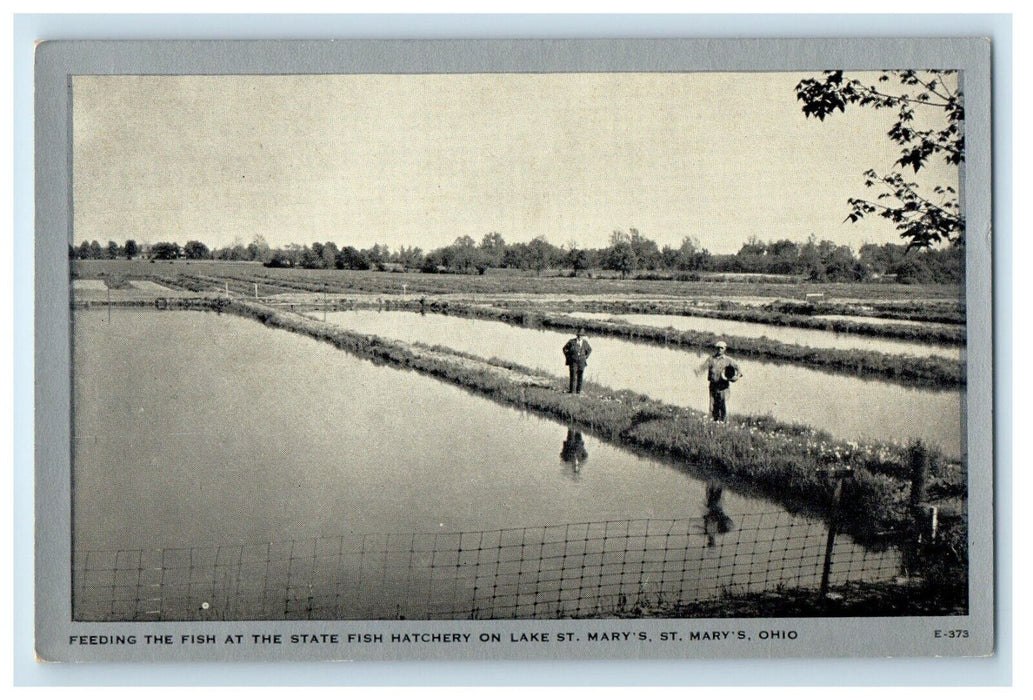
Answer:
[{"left": 35, "top": 38, "right": 993, "bottom": 661}]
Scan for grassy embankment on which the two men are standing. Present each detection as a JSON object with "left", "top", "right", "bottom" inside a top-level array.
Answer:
[{"left": 218, "top": 299, "right": 965, "bottom": 541}]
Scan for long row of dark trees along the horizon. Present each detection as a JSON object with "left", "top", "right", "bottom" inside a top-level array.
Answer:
[{"left": 68, "top": 228, "right": 965, "bottom": 283}]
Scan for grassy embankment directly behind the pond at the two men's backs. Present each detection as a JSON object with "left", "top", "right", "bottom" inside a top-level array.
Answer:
[{"left": 396, "top": 301, "right": 965, "bottom": 388}]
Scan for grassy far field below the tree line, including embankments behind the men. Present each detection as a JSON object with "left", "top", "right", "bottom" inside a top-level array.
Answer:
[{"left": 71, "top": 260, "right": 964, "bottom": 387}]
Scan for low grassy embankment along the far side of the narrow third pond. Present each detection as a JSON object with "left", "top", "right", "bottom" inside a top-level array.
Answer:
[{"left": 516, "top": 299, "right": 965, "bottom": 345}]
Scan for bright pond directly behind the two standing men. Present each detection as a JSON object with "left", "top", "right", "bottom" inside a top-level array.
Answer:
[{"left": 312, "top": 311, "right": 962, "bottom": 456}]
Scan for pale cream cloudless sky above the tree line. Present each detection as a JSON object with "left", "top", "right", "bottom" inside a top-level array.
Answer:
[{"left": 72, "top": 72, "right": 958, "bottom": 254}]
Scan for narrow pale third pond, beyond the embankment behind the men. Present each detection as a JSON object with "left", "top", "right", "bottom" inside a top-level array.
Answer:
[{"left": 568, "top": 312, "right": 962, "bottom": 360}]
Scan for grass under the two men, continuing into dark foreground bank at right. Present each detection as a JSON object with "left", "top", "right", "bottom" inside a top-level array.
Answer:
[{"left": 72, "top": 296, "right": 968, "bottom": 617}]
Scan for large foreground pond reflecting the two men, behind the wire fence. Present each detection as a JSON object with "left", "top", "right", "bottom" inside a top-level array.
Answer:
[{"left": 72, "top": 311, "right": 897, "bottom": 619}]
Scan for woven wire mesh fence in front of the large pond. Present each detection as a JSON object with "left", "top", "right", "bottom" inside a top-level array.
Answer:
[{"left": 72, "top": 511, "right": 902, "bottom": 621}]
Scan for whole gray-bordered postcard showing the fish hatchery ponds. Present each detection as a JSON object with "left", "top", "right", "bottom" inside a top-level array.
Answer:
[{"left": 36, "top": 38, "right": 994, "bottom": 662}]
